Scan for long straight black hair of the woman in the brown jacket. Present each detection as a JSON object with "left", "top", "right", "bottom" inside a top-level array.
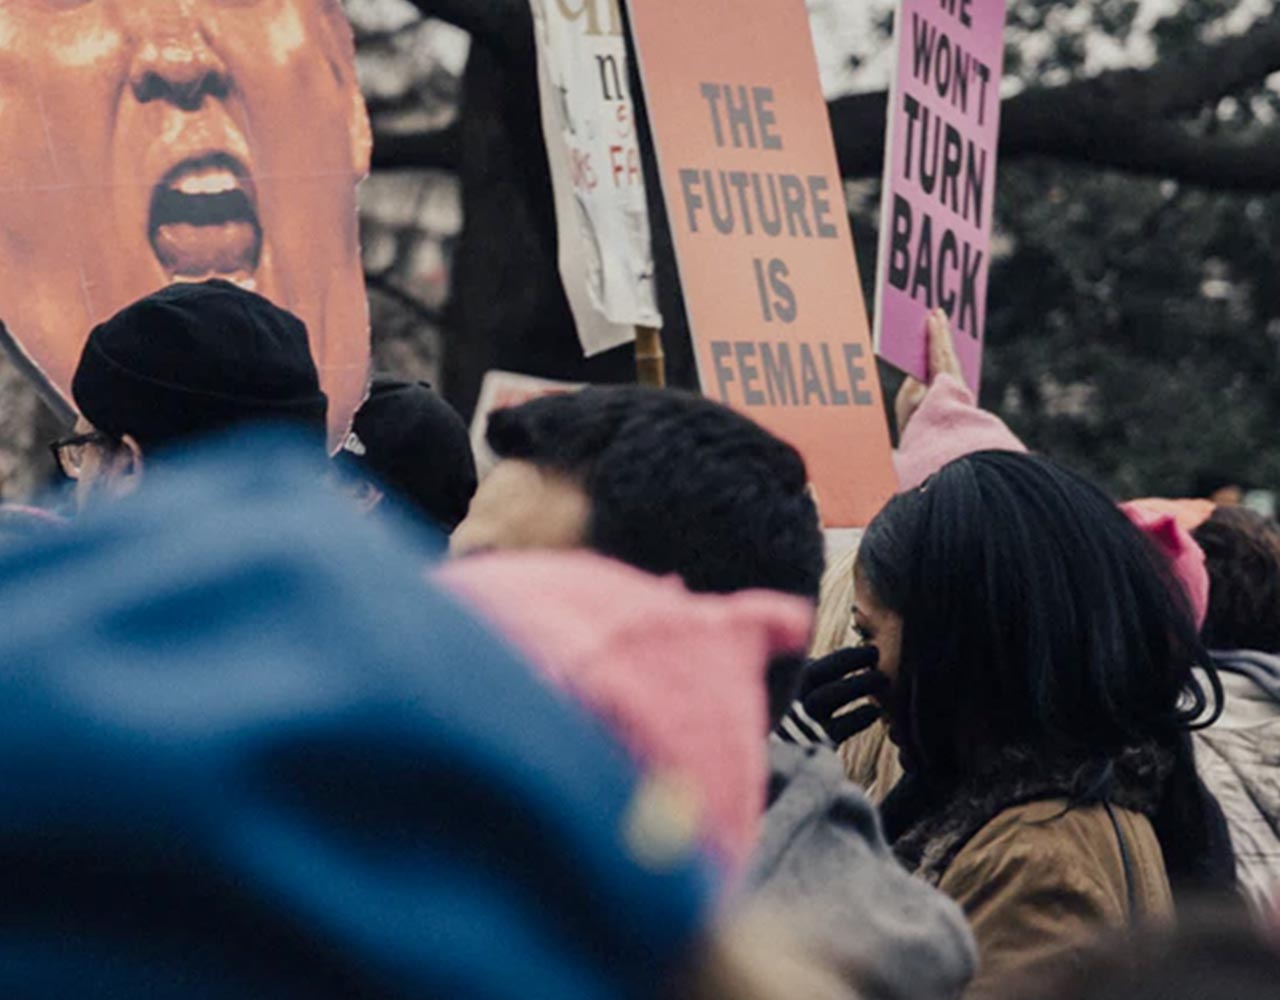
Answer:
[{"left": 858, "top": 452, "right": 1224, "bottom": 881}]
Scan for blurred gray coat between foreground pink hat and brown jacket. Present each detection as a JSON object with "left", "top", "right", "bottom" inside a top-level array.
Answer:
[{"left": 748, "top": 740, "right": 977, "bottom": 1000}]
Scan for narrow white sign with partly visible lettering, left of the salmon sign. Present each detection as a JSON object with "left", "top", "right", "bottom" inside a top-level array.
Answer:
[{"left": 529, "top": 0, "right": 662, "bottom": 356}]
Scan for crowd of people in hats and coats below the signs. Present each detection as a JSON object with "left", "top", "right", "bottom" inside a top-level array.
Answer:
[{"left": 0, "top": 280, "right": 1280, "bottom": 1000}]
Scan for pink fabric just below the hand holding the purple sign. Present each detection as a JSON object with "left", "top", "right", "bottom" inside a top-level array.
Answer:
[{"left": 893, "top": 375, "right": 1027, "bottom": 490}]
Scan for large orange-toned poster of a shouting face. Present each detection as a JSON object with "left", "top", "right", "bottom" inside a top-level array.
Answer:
[{"left": 0, "top": 0, "right": 370, "bottom": 440}]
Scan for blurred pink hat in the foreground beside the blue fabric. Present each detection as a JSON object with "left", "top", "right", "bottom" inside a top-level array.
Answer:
[{"left": 438, "top": 552, "right": 813, "bottom": 875}]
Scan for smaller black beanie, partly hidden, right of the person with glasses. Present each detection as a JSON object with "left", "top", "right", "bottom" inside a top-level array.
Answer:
[{"left": 343, "top": 375, "right": 476, "bottom": 531}]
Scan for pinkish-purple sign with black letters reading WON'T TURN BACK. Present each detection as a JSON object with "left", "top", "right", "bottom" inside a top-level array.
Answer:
[{"left": 876, "top": 0, "right": 1006, "bottom": 392}]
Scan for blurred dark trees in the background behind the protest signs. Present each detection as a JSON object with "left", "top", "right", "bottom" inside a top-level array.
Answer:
[{"left": 0, "top": 0, "right": 1280, "bottom": 498}]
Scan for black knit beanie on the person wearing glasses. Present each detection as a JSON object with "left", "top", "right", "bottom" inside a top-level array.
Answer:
[{"left": 72, "top": 280, "right": 329, "bottom": 451}]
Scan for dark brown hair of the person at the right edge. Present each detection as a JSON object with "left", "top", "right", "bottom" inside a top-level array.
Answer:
[{"left": 1193, "top": 507, "right": 1280, "bottom": 653}]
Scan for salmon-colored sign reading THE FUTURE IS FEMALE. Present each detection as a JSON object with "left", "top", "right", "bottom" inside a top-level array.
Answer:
[{"left": 630, "top": 0, "right": 897, "bottom": 528}]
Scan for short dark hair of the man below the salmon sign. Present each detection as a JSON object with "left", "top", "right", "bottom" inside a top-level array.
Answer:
[{"left": 488, "top": 385, "right": 823, "bottom": 601}]
